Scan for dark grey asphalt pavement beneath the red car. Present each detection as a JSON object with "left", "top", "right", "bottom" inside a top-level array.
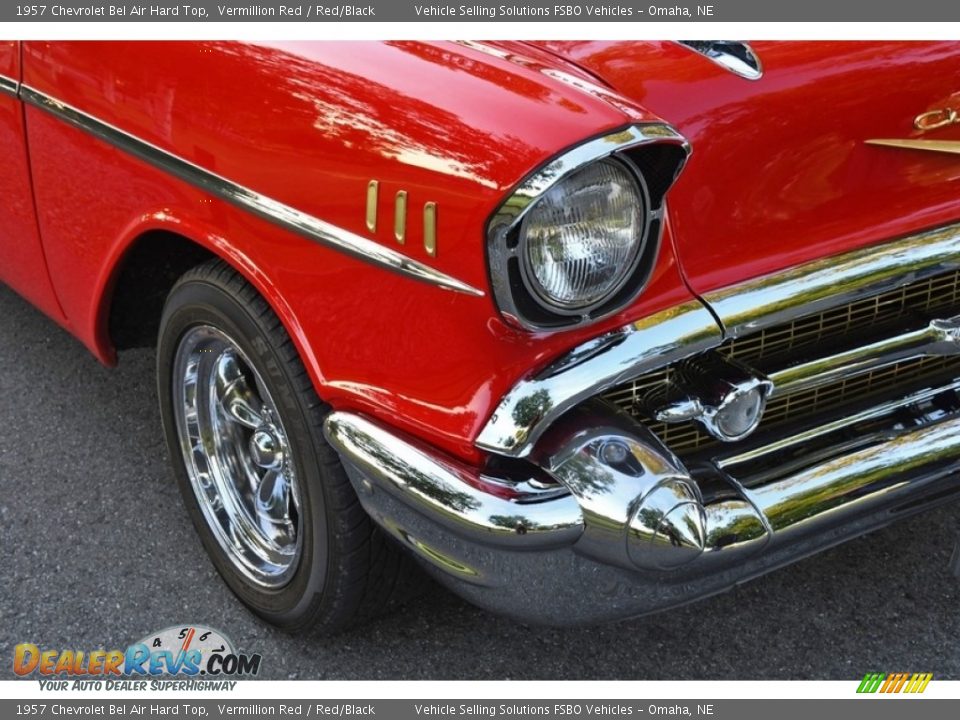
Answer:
[{"left": 0, "top": 286, "right": 960, "bottom": 680}]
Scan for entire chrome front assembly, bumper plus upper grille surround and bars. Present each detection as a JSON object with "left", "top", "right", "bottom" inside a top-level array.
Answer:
[{"left": 326, "top": 225, "right": 960, "bottom": 623}]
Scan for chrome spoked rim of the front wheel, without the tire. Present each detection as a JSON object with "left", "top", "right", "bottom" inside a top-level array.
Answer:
[{"left": 172, "top": 325, "right": 303, "bottom": 588}]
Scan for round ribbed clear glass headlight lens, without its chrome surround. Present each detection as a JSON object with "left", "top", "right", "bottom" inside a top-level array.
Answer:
[{"left": 520, "top": 159, "right": 647, "bottom": 311}]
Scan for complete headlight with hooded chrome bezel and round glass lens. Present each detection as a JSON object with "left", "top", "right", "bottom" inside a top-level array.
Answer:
[{"left": 487, "top": 123, "right": 689, "bottom": 332}]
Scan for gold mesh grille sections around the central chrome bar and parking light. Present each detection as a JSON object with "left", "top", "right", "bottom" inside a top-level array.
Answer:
[{"left": 603, "top": 272, "right": 960, "bottom": 455}]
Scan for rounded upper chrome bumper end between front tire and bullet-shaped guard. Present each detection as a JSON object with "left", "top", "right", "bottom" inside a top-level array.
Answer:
[{"left": 323, "top": 412, "right": 583, "bottom": 549}]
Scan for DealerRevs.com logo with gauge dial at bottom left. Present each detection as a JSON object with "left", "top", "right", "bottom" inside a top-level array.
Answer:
[{"left": 13, "top": 625, "right": 263, "bottom": 690}]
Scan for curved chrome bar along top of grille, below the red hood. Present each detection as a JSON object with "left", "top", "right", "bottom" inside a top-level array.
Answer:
[{"left": 476, "top": 223, "right": 960, "bottom": 457}]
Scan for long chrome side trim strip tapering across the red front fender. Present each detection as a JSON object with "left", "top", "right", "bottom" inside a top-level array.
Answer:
[{"left": 20, "top": 85, "right": 484, "bottom": 297}]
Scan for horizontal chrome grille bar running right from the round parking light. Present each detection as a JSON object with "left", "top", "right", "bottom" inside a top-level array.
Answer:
[{"left": 767, "top": 316, "right": 960, "bottom": 397}]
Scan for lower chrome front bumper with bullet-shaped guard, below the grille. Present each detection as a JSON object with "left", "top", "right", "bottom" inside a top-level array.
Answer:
[{"left": 326, "top": 402, "right": 960, "bottom": 624}]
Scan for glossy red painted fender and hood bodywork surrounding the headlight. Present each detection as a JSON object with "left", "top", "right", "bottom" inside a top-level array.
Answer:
[{"left": 9, "top": 42, "right": 960, "bottom": 462}]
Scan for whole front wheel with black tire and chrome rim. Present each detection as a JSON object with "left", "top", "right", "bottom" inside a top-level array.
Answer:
[{"left": 157, "top": 261, "right": 416, "bottom": 632}]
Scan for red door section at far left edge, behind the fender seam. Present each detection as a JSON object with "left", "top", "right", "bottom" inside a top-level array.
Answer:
[{"left": 0, "top": 41, "right": 65, "bottom": 324}]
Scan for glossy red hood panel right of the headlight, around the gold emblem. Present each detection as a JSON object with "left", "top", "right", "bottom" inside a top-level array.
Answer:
[{"left": 541, "top": 42, "right": 960, "bottom": 293}]
